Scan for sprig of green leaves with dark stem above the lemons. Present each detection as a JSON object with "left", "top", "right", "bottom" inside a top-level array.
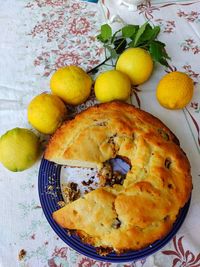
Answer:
[{"left": 88, "top": 22, "right": 170, "bottom": 73}]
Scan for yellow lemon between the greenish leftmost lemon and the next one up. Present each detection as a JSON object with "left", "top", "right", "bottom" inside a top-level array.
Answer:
[{"left": 28, "top": 93, "right": 67, "bottom": 134}]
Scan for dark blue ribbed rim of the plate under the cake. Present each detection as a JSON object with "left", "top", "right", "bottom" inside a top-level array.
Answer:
[{"left": 38, "top": 159, "right": 190, "bottom": 263}]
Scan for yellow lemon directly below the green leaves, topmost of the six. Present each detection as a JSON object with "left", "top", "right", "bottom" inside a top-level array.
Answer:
[{"left": 116, "top": 48, "right": 153, "bottom": 85}]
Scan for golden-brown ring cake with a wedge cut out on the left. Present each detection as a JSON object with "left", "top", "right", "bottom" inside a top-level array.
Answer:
[{"left": 45, "top": 102, "right": 192, "bottom": 253}]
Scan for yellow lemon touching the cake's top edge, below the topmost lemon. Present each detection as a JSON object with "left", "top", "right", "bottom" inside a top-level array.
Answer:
[{"left": 94, "top": 70, "right": 131, "bottom": 102}]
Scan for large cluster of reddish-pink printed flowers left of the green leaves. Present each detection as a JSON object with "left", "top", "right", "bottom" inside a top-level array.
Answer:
[{"left": 26, "top": 0, "right": 104, "bottom": 77}]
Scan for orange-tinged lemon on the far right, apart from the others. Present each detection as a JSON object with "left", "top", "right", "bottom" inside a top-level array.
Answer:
[{"left": 156, "top": 71, "right": 194, "bottom": 109}]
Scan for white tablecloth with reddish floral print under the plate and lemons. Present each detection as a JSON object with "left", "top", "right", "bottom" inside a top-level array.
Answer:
[{"left": 0, "top": 0, "right": 200, "bottom": 267}]
